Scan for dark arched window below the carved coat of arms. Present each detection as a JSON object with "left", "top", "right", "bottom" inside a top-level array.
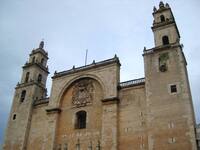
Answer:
[{"left": 75, "top": 111, "right": 87, "bottom": 129}]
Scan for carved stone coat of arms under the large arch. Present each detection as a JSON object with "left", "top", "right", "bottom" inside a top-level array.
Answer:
[{"left": 72, "top": 79, "right": 94, "bottom": 107}]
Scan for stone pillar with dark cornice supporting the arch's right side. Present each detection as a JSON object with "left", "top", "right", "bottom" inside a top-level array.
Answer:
[{"left": 101, "top": 97, "right": 119, "bottom": 150}]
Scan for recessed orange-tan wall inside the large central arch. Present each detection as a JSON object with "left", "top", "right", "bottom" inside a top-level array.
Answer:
[{"left": 56, "top": 77, "right": 103, "bottom": 149}]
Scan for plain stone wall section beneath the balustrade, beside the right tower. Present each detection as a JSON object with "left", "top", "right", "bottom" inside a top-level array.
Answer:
[{"left": 118, "top": 85, "right": 148, "bottom": 150}]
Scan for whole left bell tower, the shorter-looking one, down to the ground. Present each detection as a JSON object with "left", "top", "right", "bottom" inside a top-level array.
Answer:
[{"left": 3, "top": 41, "right": 49, "bottom": 150}]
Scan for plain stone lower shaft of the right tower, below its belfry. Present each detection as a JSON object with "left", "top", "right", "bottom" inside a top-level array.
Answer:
[{"left": 144, "top": 46, "right": 196, "bottom": 150}]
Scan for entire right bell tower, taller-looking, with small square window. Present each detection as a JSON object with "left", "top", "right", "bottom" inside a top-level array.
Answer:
[{"left": 143, "top": 1, "right": 196, "bottom": 150}]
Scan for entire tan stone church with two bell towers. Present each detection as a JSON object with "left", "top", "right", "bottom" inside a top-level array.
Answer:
[{"left": 3, "top": 2, "right": 197, "bottom": 150}]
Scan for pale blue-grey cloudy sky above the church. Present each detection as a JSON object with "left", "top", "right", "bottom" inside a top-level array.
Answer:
[{"left": 0, "top": 0, "right": 200, "bottom": 146}]
